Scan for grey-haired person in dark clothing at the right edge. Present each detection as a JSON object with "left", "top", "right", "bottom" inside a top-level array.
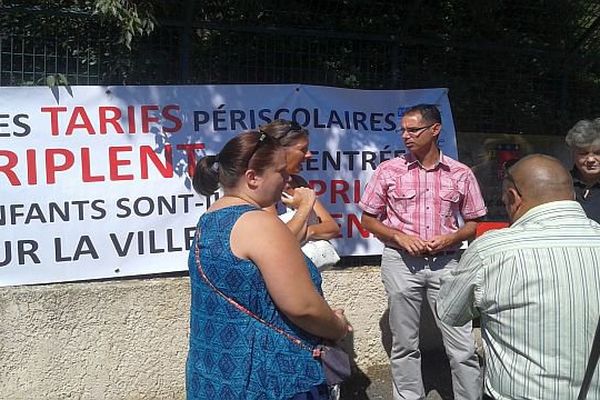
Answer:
[{"left": 565, "top": 118, "right": 600, "bottom": 222}]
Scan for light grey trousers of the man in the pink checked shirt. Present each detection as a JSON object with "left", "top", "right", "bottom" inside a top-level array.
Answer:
[{"left": 381, "top": 247, "right": 482, "bottom": 400}]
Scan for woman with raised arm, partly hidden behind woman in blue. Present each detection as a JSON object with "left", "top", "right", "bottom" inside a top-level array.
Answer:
[{"left": 260, "top": 119, "right": 340, "bottom": 250}]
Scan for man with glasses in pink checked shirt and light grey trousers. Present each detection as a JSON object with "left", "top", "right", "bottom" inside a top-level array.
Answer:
[{"left": 359, "top": 104, "right": 486, "bottom": 400}]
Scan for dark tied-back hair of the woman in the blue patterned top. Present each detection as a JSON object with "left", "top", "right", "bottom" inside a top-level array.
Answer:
[{"left": 192, "top": 131, "right": 281, "bottom": 196}]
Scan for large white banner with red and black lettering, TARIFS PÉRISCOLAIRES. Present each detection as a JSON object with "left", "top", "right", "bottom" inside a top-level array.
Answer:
[{"left": 0, "top": 85, "right": 456, "bottom": 286}]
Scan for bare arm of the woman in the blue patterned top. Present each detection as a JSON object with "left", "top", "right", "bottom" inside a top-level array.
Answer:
[{"left": 231, "top": 211, "right": 351, "bottom": 340}]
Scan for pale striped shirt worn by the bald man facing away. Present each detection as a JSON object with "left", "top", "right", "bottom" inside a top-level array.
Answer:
[{"left": 437, "top": 201, "right": 600, "bottom": 400}]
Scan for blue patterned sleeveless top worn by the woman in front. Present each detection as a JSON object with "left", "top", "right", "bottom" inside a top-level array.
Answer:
[{"left": 186, "top": 205, "right": 325, "bottom": 400}]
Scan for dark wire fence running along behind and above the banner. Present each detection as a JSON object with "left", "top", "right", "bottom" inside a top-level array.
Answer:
[{"left": 0, "top": 0, "right": 600, "bottom": 135}]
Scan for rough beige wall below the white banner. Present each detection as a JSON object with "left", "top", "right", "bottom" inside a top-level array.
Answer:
[{"left": 0, "top": 267, "right": 404, "bottom": 400}]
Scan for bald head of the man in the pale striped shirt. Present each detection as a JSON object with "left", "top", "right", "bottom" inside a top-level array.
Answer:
[{"left": 509, "top": 154, "right": 573, "bottom": 208}]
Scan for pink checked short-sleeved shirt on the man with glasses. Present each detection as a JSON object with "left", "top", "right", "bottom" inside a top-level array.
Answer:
[{"left": 359, "top": 152, "right": 487, "bottom": 240}]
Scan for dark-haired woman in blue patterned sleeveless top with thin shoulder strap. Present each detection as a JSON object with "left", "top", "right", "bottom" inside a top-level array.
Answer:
[{"left": 186, "top": 131, "right": 351, "bottom": 400}]
